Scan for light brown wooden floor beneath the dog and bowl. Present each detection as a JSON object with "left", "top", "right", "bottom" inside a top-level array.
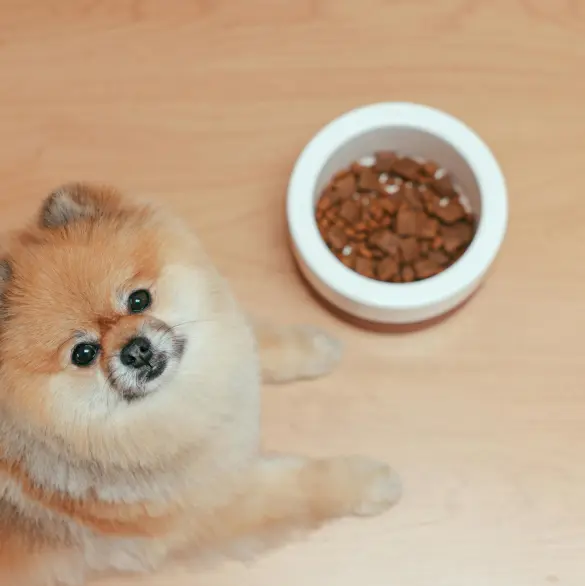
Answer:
[{"left": 0, "top": 0, "right": 585, "bottom": 586}]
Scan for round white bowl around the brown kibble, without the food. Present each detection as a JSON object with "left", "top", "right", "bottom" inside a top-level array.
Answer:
[{"left": 287, "top": 103, "right": 508, "bottom": 324}]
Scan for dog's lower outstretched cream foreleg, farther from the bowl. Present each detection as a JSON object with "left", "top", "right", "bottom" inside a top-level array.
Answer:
[{"left": 202, "top": 456, "right": 401, "bottom": 545}]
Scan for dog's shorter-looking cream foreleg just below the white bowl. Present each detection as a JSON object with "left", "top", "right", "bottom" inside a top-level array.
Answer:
[{"left": 253, "top": 322, "right": 341, "bottom": 383}]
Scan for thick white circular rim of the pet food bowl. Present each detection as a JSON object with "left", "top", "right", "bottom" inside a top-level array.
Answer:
[{"left": 286, "top": 102, "right": 508, "bottom": 310}]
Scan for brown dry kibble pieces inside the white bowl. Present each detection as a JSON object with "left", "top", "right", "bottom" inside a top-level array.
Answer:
[{"left": 316, "top": 151, "right": 476, "bottom": 283}]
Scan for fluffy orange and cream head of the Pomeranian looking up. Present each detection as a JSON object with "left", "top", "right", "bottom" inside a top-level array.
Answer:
[{"left": 0, "top": 184, "right": 248, "bottom": 462}]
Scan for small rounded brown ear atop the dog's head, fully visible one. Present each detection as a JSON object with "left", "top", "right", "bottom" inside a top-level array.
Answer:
[{"left": 39, "top": 183, "right": 120, "bottom": 228}]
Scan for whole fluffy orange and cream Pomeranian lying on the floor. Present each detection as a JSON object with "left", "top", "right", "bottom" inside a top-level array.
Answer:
[{"left": 0, "top": 184, "right": 400, "bottom": 586}]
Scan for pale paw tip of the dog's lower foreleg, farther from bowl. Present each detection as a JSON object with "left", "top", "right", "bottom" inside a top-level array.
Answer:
[{"left": 342, "top": 456, "right": 402, "bottom": 517}]
